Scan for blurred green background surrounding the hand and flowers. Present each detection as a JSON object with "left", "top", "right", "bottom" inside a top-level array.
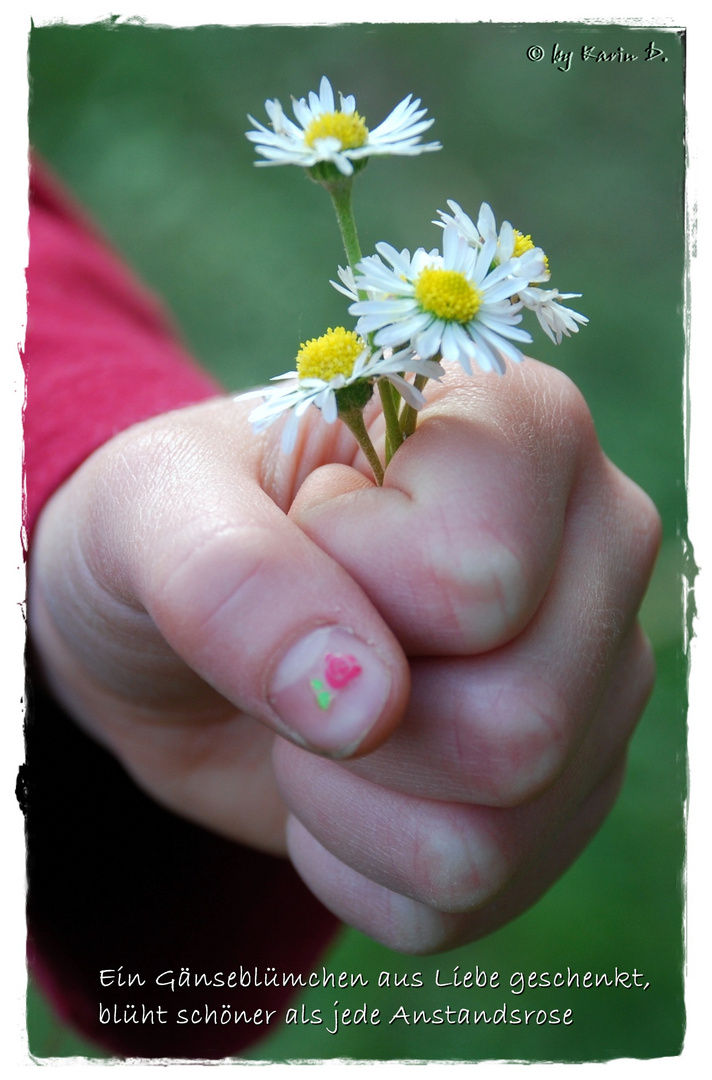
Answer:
[{"left": 28, "top": 16, "right": 694, "bottom": 1061}]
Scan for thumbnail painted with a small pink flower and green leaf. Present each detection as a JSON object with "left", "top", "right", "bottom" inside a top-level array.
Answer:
[{"left": 269, "top": 626, "right": 391, "bottom": 757}]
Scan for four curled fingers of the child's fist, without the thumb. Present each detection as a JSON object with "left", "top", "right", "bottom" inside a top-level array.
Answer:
[{"left": 276, "top": 361, "right": 659, "bottom": 951}]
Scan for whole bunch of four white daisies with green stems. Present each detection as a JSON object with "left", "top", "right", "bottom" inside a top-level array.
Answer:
[{"left": 242, "top": 78, "right": 588, "bottom": 484}]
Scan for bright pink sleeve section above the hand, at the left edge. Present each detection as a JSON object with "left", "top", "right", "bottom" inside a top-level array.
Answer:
[{"left": 24, "top": 156, "right": 219, "bottom": 532}]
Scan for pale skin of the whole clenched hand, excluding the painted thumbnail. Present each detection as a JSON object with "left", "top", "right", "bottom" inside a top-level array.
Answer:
[{"left": 29, "top": 360, "right": 660, "bottom": 954}]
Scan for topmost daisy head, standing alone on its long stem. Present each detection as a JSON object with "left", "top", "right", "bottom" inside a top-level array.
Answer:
[{"left": 246, "top": 76, "right": 441, "bottom": 176}]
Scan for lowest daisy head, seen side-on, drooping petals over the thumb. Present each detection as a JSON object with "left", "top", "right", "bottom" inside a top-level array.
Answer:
[{"left": 250, "top": 326, "right": 443, "bottom": 454}]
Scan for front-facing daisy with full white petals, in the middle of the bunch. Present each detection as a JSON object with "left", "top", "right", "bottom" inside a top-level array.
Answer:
[{"left": 349, "top": 225, "right": 543, "bottom": 374}]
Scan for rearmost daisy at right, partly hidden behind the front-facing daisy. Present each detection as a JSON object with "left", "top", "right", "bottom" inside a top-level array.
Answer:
[{"left": 434, "top": 199, "right": 588, "bottom": 345}]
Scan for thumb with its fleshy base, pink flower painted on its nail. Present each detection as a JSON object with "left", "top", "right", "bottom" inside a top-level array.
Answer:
[{"left": 33, "top": 402, "right": 408, "bottom": 757}]
